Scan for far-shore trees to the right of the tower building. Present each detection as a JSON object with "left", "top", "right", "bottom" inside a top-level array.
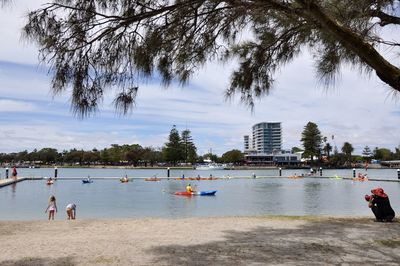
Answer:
[{"left": 292, "top": 122, "right": 400, "bottom": 167}]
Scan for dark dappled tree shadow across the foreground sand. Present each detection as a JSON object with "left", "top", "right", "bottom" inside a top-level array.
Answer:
[{"left": 147, "top": 219, "right": 400, "bottom": 265}]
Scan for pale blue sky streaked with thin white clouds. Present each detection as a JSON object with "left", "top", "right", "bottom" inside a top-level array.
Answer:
[{"left": 0, "top": 0, "right": 400, "bottom": 155}]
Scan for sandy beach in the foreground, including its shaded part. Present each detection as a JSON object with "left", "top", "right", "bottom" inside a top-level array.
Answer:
[{"left": 0, "top": 217, "right": 400, "bottom": 265}]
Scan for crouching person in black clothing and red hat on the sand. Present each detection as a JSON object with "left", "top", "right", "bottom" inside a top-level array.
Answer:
[{"left": 365, "top": 187, "right": 395, "bottom": 222}]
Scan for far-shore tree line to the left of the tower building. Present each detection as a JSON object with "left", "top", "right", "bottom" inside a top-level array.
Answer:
[{"left": 0, "top": 125, "right": 244, "bottom": 167}]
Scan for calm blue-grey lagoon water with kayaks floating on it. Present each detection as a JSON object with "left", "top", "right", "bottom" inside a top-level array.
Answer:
[{"left": 0, "top": 168, "right": 400, "bottom": 220}]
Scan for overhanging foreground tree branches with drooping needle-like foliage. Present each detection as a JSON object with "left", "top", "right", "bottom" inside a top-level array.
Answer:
[{"left": 17, "top": 0, "right": 400, "bottom": 116}]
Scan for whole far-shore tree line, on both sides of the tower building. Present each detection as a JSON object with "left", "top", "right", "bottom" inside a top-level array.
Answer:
[{"left": 0, "top": 122, "right": 400, "bottom": 167}]
